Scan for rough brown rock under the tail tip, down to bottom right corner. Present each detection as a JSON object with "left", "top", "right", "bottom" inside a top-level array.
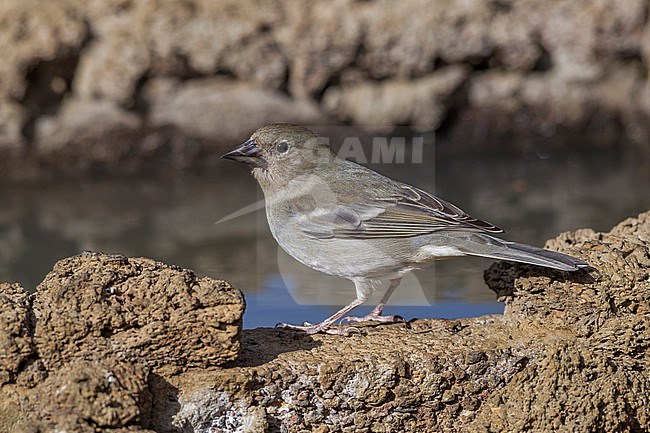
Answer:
[{"left": 474, "top": 212, "right": 650, "bottom": 431}]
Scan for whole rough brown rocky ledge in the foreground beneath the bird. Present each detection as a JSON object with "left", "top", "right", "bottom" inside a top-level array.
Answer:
[{"left": 0, "top": 212, "right": 650, "bottom": 433}]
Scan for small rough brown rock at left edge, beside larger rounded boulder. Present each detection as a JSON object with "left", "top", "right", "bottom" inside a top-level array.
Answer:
[{"left": 0, "top": 283, "right": 34, "bottom": 386}]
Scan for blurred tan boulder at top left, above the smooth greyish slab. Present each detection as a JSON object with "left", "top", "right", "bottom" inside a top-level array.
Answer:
[{"left": 76, "top": 0, "right": 287, "bottom": 104}]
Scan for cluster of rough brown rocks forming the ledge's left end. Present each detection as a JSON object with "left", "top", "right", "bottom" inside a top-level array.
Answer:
[{"left": 0, "top": 253, "right": 244, "bottom": 432}]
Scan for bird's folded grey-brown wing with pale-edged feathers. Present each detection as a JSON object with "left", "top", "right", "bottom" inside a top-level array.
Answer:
[{"left": 300, "top": 184, "right": 503, "bottom": 239}]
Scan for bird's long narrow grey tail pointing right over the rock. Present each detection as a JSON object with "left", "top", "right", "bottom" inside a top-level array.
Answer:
[{"left": 456, "top": 234, "right": 589, "bottom": 271}]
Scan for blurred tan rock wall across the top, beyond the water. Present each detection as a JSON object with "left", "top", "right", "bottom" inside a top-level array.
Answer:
[{"left": 0, "top": 0, "right": 650, "bottom": 177}]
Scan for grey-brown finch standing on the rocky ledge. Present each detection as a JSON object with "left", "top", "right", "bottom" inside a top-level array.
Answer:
[{"left": 222, "top": 123, "right": 588, "bottom": 335}]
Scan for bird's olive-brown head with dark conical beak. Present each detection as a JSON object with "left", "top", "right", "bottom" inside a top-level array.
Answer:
[{"left": 221, "top": 123, "right": 334, "bottom": 188}]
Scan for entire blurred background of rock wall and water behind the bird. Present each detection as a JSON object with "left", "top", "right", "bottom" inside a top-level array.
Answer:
[{"left": 0, "top": 0, "right": 650, "bottom": 328}]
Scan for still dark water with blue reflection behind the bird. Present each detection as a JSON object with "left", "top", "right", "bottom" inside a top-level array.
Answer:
[{"left": 0, "top": 143, "right": 650, "bottom": 328}]
